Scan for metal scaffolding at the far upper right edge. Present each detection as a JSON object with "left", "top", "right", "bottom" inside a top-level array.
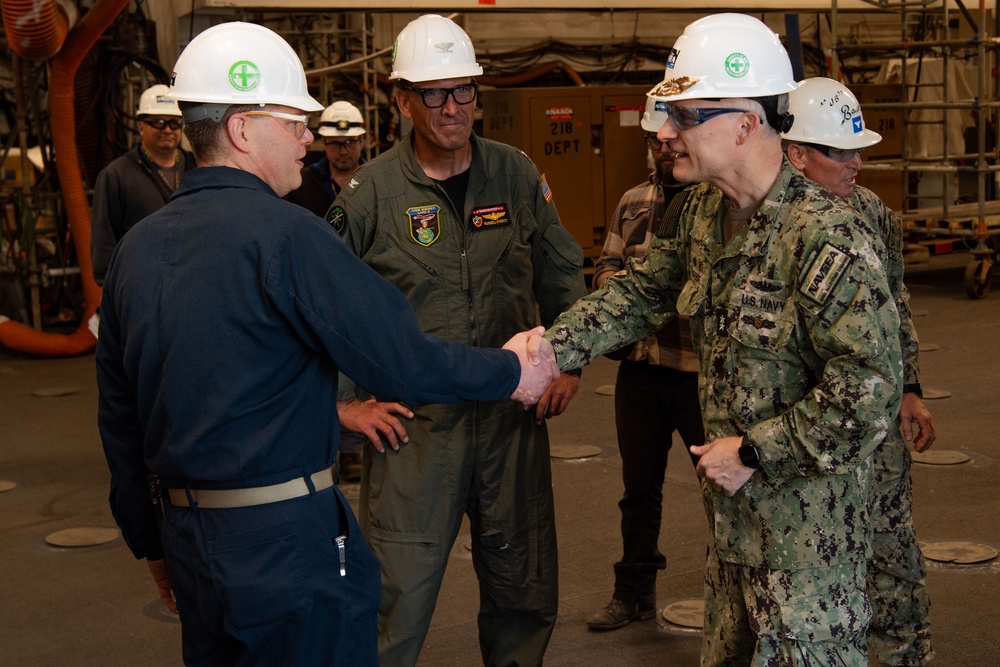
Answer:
[{"left": 831, "top": 0, "right": 1000, "bottom": 298}]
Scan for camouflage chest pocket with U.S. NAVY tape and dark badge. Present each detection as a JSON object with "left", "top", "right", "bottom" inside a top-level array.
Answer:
[{"left": 730, "top": 277, "right": 794, "bottom": 351}]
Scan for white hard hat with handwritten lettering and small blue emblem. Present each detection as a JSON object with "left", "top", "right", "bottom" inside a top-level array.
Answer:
[{"left": 782, "top": 76, "right": 882, "bottom": 149}]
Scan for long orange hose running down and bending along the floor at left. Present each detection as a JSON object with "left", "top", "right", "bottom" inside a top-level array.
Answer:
[{"left": 0, "top": 0, "right": 129, "bottom": 357}]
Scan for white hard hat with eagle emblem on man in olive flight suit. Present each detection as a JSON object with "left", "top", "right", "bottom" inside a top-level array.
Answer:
[{"left": 389, "top": 14, "right": 483, "bottom": 83}]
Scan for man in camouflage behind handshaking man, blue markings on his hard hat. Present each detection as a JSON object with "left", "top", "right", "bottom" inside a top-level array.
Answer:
[{"left": 784, "top": 77, "right": 934, "bottom": 667}]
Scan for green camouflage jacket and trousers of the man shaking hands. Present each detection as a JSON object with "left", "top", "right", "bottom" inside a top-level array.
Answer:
[{"left": 546, "top": 160, "right": 902, "bottom": 666}]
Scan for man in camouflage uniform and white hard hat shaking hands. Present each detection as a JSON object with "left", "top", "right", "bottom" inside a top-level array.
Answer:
[{"left": 546, "top": 14, "right": 902, "bottom": 667}]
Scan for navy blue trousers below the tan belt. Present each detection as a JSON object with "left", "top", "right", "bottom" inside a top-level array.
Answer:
[{"left": 161, "top": 487, "right": 381, "bottom": 667}]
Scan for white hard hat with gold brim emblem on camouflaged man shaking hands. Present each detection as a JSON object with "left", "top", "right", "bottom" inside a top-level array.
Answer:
[{"left": 647, "top": 14, "right": 796, "bottom": 102}]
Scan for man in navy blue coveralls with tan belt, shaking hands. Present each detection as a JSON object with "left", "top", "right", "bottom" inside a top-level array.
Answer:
[{"left": 97, "top": 23, "right": 559, "bottom": 667}]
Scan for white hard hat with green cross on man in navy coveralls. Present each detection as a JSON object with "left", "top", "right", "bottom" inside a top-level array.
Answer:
[{"left": 170, "top": 22, "right": 323, "bottom": 122}]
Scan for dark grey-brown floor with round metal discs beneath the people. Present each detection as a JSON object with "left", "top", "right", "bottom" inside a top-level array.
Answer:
[{"left": 0, "top": 256, "right": 1000, "bottom": 667}]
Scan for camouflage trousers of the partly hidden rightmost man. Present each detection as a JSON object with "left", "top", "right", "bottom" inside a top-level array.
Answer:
[{"left": 868, "top": 433, "right": 934, "bottom": 667}]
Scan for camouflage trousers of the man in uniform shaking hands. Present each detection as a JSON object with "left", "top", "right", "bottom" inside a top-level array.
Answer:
[{"left": 701, "top": 547, "right": 871, "bottom": 667}]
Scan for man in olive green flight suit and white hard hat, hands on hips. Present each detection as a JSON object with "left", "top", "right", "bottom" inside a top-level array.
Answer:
[{"left": 328, "top": 15, "right": 586, "bottom": 667}]
